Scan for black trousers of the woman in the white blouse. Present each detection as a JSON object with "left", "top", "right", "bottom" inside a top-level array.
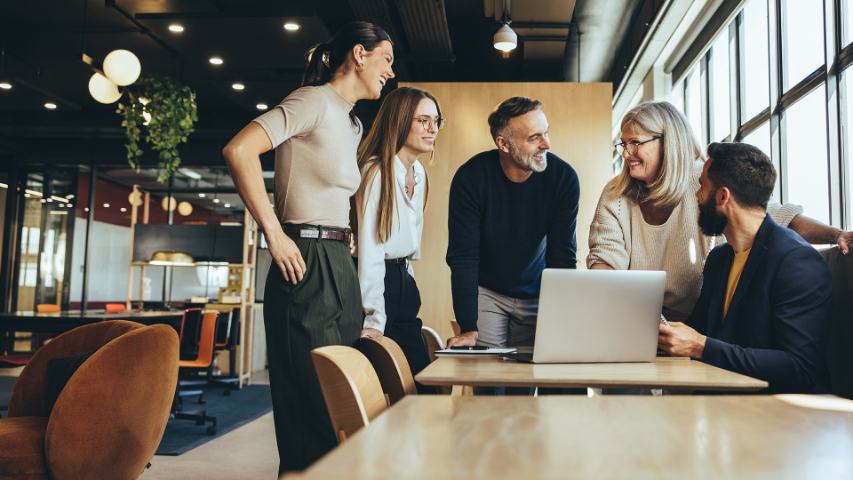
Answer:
[{"left": 385, "top": 262, "right": 432, "bottom": 384}]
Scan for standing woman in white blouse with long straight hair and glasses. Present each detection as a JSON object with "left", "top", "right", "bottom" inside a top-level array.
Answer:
[{"left": 356, "top": 87, "right": 444, "bottom": 378}]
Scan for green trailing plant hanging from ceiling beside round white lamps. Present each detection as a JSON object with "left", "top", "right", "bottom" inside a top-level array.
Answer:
[{"left": 116, "top": 76, "right": 198, "bottom": 183}]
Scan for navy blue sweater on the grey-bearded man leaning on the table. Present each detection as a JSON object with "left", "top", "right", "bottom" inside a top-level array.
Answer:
[{"left": 447, "top": 150, "right": 580, "bottom": 332}]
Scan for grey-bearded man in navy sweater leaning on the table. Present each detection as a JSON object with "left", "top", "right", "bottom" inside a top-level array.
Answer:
[{"left": 447, "top": 97, "right": 580, "bottom": 347}]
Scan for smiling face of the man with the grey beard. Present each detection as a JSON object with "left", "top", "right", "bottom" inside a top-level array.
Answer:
[{"left": 498, "top": 108, "right": 551, "bottom": 173}]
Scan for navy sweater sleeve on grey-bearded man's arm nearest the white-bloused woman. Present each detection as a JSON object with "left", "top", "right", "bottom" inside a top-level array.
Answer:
[{"left": 447, "top": 166, "right": 481, "bottom": 333}]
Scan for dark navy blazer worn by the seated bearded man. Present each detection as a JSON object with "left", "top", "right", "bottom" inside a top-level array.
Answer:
[{"left": 687, "top": 216, "right": 832, "bottom": 392}]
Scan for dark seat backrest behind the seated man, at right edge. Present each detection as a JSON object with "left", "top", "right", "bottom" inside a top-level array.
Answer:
[{"left": 821, "top": 247, "right": 853, "bottom": 398}]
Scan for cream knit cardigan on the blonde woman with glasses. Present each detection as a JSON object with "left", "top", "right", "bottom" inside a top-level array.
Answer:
[{"left": 586, "top": 162, "right": 802, "bottom": 321}]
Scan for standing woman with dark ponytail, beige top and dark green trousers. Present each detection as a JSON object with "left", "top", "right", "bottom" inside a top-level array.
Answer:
[{"left": 223, "top": 22, "right": 394, "bottom": 473}]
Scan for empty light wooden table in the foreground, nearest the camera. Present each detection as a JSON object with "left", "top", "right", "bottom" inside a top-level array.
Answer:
[{"left": 297, "top": 395, "right": 853, "bottom": 480}]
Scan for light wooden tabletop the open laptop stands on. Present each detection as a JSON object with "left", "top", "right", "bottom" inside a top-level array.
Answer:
[{"left": 415, "top": 357, "right": 767, "bottom": 392}]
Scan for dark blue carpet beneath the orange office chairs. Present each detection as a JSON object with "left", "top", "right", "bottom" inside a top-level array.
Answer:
[{"left": 157, "top": 385, "right": 272, "bottom": 455}]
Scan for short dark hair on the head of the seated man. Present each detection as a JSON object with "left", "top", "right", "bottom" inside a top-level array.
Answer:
[{"left": 708, "top": 143, "right": 776, "bottom": 209}]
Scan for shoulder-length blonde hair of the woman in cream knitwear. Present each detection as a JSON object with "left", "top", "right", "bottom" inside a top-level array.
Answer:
[{"left": 605, "top": 102, "right": 704, "bottom": 208}]
